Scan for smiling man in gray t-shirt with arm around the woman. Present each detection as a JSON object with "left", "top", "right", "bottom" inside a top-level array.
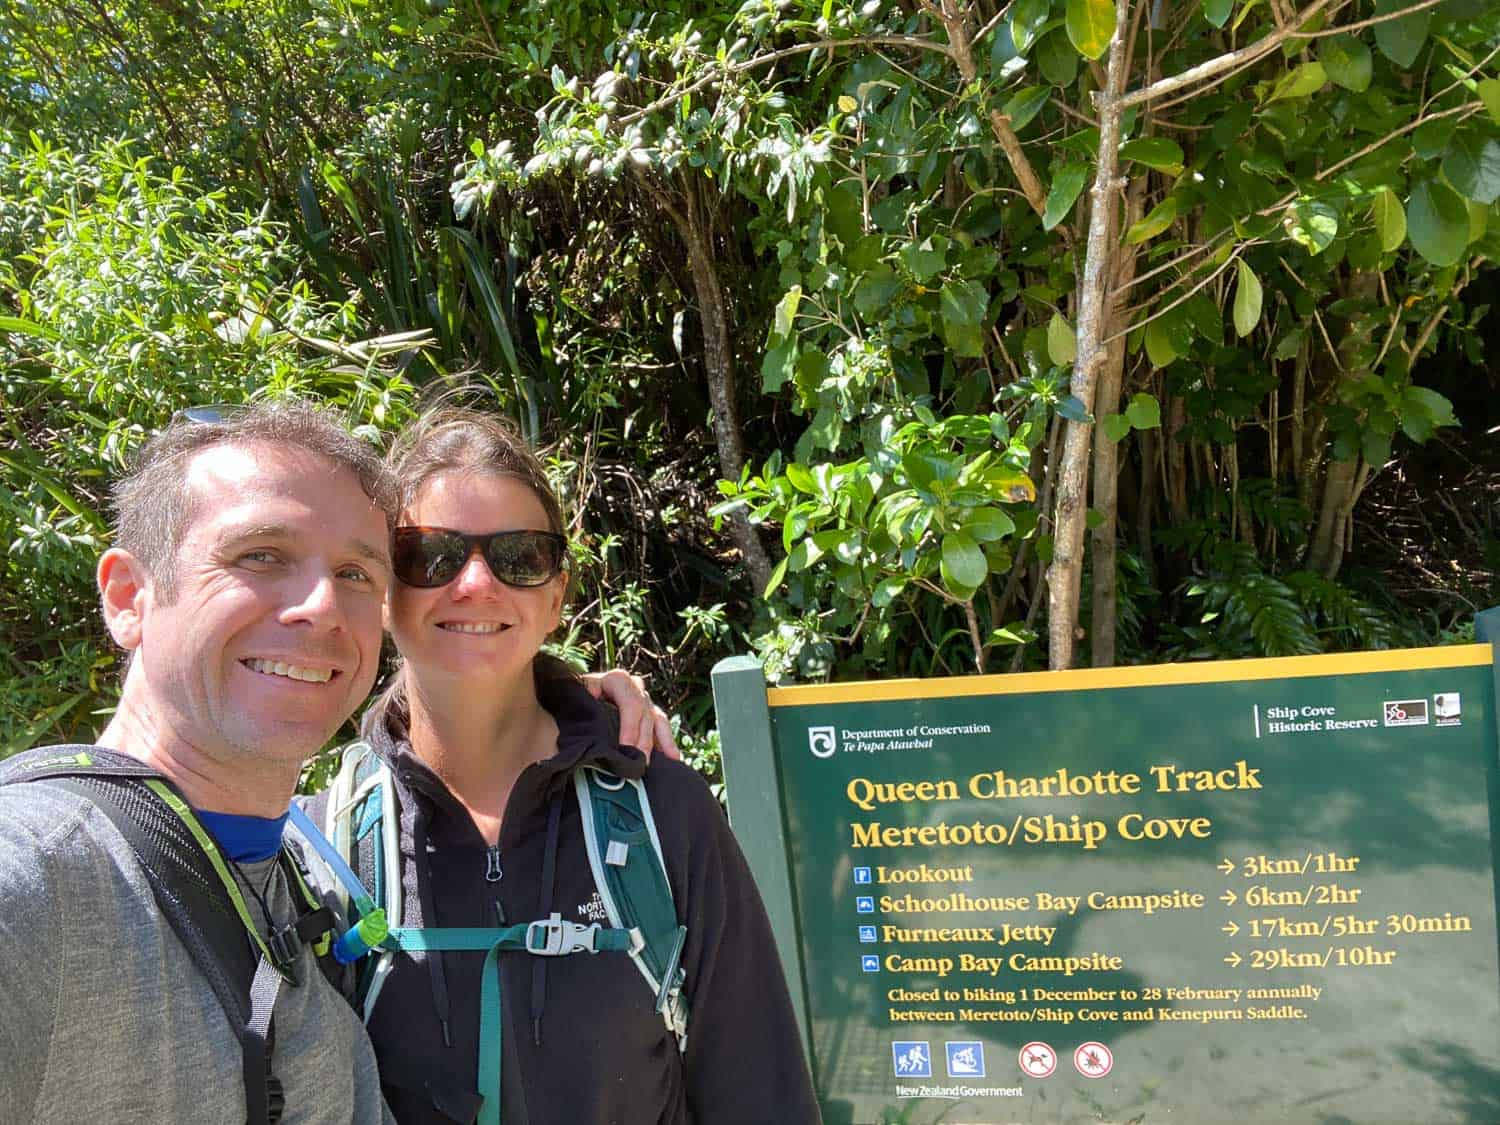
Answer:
[{"left": 0, "top": 405, "right": 659, "bottom": 1125}]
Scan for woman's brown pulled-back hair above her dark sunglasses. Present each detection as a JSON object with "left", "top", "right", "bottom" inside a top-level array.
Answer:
[{"left": 360, "top": 407, "right": 573, "bottom": 737}]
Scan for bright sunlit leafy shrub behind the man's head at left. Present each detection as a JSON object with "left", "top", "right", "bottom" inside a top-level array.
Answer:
[{"left": 0, "top": 137, "right": 414, "bottom": 752}]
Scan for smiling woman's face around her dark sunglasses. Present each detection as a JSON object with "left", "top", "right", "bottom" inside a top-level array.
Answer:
[{"left": 386, "top": 473, "right": 567, "bottom": 693}]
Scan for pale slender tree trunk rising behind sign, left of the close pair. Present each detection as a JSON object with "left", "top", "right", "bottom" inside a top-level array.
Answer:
[{"left": 1047, "top": 3, "right": 1130, "bottom": 669}]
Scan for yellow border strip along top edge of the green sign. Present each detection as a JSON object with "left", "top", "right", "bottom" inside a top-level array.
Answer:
[{"left": 765, "top": 644, "right": 1494, "bottom": 707}]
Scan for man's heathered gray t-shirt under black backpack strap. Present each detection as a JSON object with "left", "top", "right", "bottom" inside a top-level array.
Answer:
[{"left": 0, "top": 782, "right": 395, "bottom": 1125}]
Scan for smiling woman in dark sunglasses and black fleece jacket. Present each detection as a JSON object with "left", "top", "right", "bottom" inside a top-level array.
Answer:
[{"left": 307, "top": 411, "right": 818, "bottom": 1125}]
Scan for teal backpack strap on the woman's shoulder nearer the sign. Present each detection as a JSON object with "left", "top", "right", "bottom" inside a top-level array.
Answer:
[{"left": 573, "top": 767, "right": 689, "bottom": 1050}]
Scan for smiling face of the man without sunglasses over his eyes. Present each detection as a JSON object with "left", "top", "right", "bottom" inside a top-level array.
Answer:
[{"left": 135, "top": 444, "right": 390, "bottom": 764}]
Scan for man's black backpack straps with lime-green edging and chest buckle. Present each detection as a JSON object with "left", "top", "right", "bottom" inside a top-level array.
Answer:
[{"left": 0, "top": 746, "right": 335, "bottom": 1125}]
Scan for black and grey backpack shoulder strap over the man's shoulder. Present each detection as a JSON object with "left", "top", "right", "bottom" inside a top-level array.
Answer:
[{"left": 0, "top": 746, "right": 285, "bottom": 1125}]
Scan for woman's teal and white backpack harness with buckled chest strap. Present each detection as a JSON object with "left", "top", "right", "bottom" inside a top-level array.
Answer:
[{"left": 291, "top": 741, "right": 689, "bottom": 1125}]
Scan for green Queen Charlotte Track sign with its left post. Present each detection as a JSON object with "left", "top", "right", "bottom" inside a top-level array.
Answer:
[{"left": 716, "top": 627, "right": 1500, "bottom": 1125}]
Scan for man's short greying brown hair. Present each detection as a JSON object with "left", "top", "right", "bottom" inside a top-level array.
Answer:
[{"left": 113, "top": 399, "right": 396, "bottom": 602}]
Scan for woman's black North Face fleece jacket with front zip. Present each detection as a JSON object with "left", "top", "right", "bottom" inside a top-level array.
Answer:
[{"left": 354, "top": 680, "right": 819, "bottom": 1125}]
